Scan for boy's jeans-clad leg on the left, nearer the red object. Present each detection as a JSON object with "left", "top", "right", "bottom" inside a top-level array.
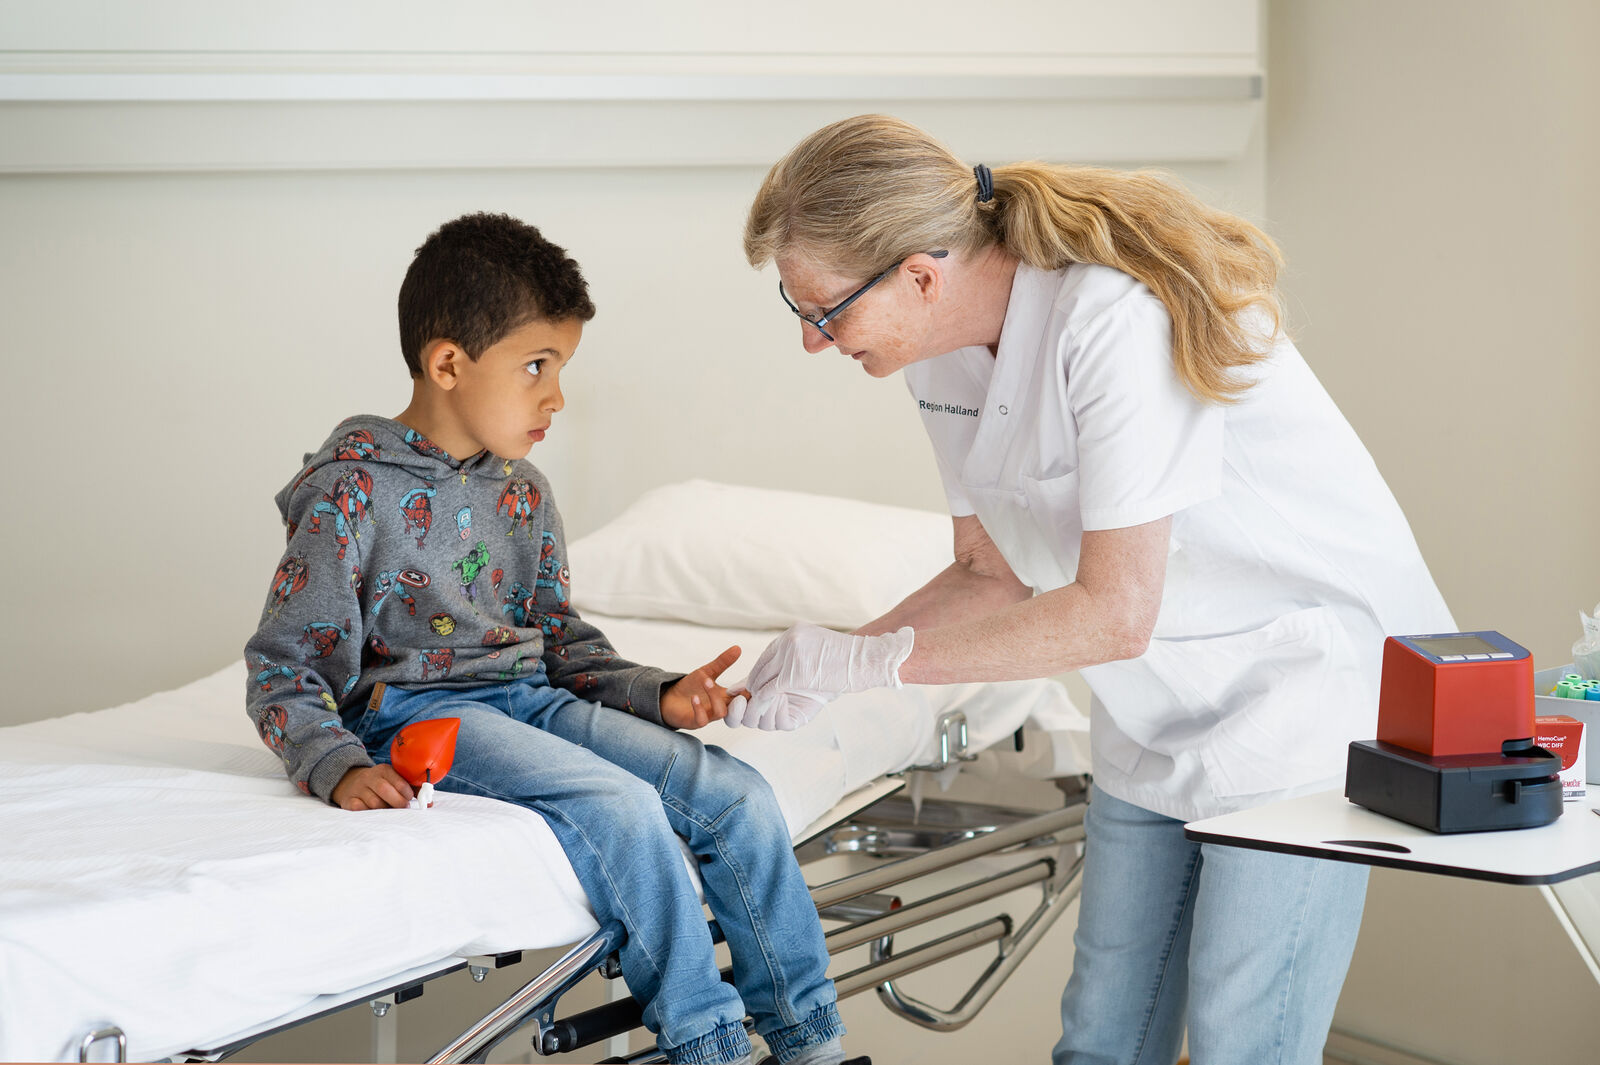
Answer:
[{"left": 357, "top": 683, "right": 750, "bottom": 1062}]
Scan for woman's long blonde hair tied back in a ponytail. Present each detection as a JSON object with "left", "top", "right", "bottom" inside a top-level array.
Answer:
[{"left": 744, "top": 115, "right": 1283, "bottom": 403}]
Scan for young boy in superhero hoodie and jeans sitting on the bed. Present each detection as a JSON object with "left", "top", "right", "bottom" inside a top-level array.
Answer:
[{"left": 245, "top": 214, "right": 864, "bottom": 1065}]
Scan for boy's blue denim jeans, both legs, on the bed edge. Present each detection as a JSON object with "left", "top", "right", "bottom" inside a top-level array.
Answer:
[{"left": 352, "top": 668, "right": 843, "bottom": 1062}]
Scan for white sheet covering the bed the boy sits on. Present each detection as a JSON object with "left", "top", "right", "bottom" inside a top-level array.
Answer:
[{"left": 0, "top": 616, "right": 1088, "bottom": 1060}]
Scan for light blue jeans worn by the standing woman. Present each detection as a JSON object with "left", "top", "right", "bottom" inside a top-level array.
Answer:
[{"left": 1054, "top": 788, "right": 1366, "bottom": 1065}]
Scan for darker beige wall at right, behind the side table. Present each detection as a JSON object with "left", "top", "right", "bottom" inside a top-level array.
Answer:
[{"left": 1267, "top": 0, "right": 1600, "bottom": 1065}]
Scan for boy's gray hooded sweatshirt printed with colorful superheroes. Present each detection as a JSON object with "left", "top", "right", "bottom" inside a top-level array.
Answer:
[{"left": 245, "top": 414, "right": 682, "bottom": 801}]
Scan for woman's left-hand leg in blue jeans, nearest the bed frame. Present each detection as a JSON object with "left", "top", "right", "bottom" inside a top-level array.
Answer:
[{"left": 1054, "top": 788, "right": 1203, "bottom": 1065}]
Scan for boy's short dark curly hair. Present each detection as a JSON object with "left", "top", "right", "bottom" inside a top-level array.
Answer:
[{"left": 400, "top": 213, "right": 595, "bottom": 377}]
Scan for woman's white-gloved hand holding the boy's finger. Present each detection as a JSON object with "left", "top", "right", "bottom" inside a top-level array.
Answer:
[{"left": 725, "top": 624, "right": 915, "bottom": 731}]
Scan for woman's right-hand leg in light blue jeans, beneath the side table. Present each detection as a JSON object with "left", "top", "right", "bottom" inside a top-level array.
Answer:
[{"left": 1189, "top": 844, "right": 1366, "bottom": 1065}]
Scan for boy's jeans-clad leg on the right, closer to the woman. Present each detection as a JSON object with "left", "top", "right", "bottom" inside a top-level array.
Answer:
[{"left": 538, "top": 702, "right": 845, "bottom": 1062}]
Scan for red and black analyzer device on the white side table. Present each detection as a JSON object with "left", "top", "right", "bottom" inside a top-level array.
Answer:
[{"left": 1344, "top": 632, "right": 1562, "bottom": 833}]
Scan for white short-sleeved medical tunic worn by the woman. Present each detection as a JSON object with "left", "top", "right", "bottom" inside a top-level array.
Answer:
[{"left": 904, "top": 264, "right": 1454, "bottom": 820}]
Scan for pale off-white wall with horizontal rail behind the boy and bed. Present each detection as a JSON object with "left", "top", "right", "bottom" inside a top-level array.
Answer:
[{"left": 0, "top": 0, "right": 1266, "bottom": 723}]
